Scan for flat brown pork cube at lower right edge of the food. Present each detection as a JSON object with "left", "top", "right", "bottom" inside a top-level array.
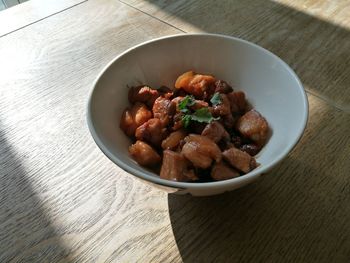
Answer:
[{"left": 222, "top": 147, "right": 258, "bottom": 173}]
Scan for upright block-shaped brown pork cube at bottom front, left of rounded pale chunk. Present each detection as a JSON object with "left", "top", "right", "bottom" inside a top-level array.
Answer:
[{"left": 160, "top": 150, "right": 198, "bottom": 182}]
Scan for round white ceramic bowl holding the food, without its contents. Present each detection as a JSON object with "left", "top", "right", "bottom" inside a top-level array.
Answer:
[{"left": 87, "top": 34, "right": 308, "bottom": 195}]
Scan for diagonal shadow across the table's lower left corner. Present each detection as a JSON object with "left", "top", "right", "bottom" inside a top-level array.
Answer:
[{"left": 0, "top": 128, "right": 69, "bottom": 262}]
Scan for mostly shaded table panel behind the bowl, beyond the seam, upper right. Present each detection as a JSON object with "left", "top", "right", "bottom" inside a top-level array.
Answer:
[{"left": 122, "top": 0, "right": 350, "bottom": 112}]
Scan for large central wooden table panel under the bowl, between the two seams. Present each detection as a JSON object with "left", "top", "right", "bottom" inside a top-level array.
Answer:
[{"left": 0, "top": 0, "right": 350, "bottom": 262}]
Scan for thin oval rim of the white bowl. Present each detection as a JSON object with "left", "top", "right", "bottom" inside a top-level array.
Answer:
[{"left": 86, "top": 33, "right": 309, "bottom": 189}]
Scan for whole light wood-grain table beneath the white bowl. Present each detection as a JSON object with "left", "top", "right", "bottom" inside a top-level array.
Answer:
[{"left": 0, "top": 0, "right": 350, "bottom": 263}]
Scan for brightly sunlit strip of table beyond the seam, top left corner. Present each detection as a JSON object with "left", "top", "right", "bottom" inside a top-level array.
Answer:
[{"left": 0, "top": 0, "right": 87, "bottom": 37}]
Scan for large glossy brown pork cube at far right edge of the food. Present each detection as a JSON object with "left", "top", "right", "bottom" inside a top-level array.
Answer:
[{"left": 236, "top": 110, "right": 269, "bottom": 146}]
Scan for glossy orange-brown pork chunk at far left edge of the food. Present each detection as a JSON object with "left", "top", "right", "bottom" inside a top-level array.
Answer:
[{"left": 120, "top": 102, "right": 152, "bottom": 136}]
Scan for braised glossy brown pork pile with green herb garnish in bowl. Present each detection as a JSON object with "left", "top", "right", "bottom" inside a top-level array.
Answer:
[{"left": 120, "top": 71, "right": 269, "bottom": 182}]
